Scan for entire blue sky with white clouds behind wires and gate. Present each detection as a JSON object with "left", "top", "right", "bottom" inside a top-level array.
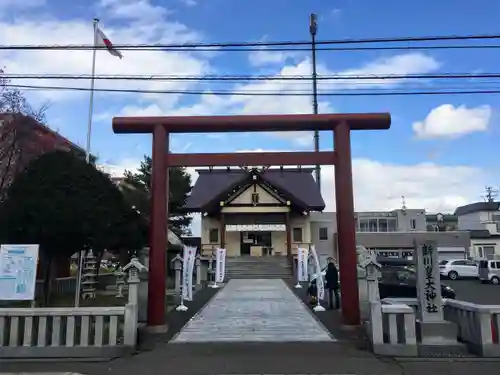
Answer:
[{"left": 0, "top": 0, "right": 500, "bottom": 217}]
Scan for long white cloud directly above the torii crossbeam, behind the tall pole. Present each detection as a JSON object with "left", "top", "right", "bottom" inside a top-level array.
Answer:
[{"left": 114, "top": 53, "right": 440, "bottom": 147}]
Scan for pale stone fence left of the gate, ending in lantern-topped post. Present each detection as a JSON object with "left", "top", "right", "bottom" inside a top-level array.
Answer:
[{"left": 0, "top": 259, "right": 143, "bottom": 359}]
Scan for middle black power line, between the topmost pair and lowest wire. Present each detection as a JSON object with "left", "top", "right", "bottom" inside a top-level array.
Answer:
[{"left": 0, "top": 73, "right": 500, "bottom": 82}]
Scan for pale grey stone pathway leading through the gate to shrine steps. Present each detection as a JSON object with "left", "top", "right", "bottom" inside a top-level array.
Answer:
[{"left": 171, "top": 279, "right": 335, "bottom": 343}]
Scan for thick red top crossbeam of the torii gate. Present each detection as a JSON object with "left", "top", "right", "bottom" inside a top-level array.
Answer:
[{"left": 113, "top": 113, "right": 391, "bottom": 134}]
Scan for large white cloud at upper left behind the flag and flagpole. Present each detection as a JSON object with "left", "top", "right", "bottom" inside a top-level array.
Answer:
[{"left": 0, "top": 0, "right": 211, "bottom": 110}]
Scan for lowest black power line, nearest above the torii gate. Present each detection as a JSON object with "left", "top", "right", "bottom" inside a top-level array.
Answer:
[{"left": 4, "top": 84, "right": 500, "bottom": 96}]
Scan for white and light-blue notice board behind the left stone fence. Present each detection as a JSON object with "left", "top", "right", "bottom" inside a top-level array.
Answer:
[{"left": 0, "top": 245, "right": 39, "bottom": 301}]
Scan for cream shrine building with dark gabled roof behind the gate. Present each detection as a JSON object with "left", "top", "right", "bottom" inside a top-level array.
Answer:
[{"left": 187, "top": 168, "right": 325, "bottom": 257}]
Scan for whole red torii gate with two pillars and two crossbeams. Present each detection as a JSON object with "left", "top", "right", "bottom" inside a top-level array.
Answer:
[{"left": 113, "top": 113, "right": 391, "bottom": 328}]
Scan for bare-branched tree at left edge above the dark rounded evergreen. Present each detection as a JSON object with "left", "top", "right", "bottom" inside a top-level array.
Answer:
[{"left": 0, "top": 69, "right": 54, "bottom": 201}]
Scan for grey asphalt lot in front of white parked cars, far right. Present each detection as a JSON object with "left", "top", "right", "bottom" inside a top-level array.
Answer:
[{"left": 442, "top": 279, "right": 500, "bottom": 305}]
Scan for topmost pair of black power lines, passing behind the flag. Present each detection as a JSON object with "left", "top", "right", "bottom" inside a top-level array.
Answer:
[{"left": 0, "top": 34, "right": 500, "bottom": 50}]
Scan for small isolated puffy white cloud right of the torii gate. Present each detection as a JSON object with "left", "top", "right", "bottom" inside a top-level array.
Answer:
[{"left": 413, "top": 104, "right": 492, "bottom": 138}]
